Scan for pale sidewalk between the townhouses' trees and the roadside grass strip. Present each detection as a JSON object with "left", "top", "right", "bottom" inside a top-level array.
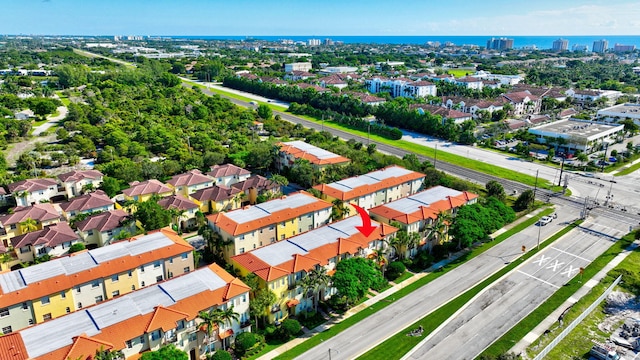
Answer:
[{"left": 258, "top": 208, "right": 545, "bottom": 360}]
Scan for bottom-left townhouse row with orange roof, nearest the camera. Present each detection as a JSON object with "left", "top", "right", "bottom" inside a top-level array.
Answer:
[{"left": 0, "top": 264, "right": 251, "bottom": 360}]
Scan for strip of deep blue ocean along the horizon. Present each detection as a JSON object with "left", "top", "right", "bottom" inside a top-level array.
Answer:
[{"left": 171, "top": 35, "right": 640, "bottom": 50}]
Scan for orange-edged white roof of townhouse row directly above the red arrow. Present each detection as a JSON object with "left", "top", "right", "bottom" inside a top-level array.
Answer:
[{"left": 313, "top": 165, "right": 425, "bottom": 201}]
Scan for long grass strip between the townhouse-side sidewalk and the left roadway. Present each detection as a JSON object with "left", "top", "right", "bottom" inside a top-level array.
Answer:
[{"left": 276, "top": 209, "right": 553, "bottom": 359}]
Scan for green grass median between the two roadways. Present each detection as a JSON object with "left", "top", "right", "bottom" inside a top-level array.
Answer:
[{"left": 358, "top": 219, "right": 577, "bottom": 360}]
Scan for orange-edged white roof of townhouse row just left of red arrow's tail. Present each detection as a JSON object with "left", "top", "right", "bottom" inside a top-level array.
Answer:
[{"left": 207, "top": 191, "right": 332, "bottom": 236}]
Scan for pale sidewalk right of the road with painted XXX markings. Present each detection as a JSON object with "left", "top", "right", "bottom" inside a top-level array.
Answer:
[{"left": 509, "top": 240, "right": 640, "bottom": 359}]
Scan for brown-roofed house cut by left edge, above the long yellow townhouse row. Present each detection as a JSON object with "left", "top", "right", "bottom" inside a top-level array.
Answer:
[{"left": 0, "top": 203, "right": 61, "bottom": 252}]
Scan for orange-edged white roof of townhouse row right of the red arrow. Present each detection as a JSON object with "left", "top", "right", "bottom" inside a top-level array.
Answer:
[{"left": 369, "top": 186, "right": 478, "bottom": 224}]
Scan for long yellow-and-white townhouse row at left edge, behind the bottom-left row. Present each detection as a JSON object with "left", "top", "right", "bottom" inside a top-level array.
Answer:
[{"left": 0, "top": 229, "right": 194, "bottom": 334}]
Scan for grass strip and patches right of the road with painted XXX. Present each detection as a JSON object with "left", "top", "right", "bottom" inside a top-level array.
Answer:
[{"left": 481, "top": 231, "right": 633, "bottom": 358}]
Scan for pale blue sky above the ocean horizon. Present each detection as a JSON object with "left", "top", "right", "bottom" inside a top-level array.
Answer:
[{"left": 0, "top": 0, "right": 640, "bottom": 36}]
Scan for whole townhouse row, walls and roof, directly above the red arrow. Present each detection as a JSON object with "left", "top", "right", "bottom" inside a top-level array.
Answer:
[{"left": 313, "top": 165, "right": 425, "bottom": 216}]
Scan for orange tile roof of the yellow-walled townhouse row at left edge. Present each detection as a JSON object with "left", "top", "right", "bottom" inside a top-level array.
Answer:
[{"left": 0, "top": 228, "right": 193, "bottom": 308}]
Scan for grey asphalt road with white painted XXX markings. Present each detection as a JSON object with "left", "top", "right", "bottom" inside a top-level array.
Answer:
[{"left": 403, "top": 214, "right": 627, "bottom": 359}]
